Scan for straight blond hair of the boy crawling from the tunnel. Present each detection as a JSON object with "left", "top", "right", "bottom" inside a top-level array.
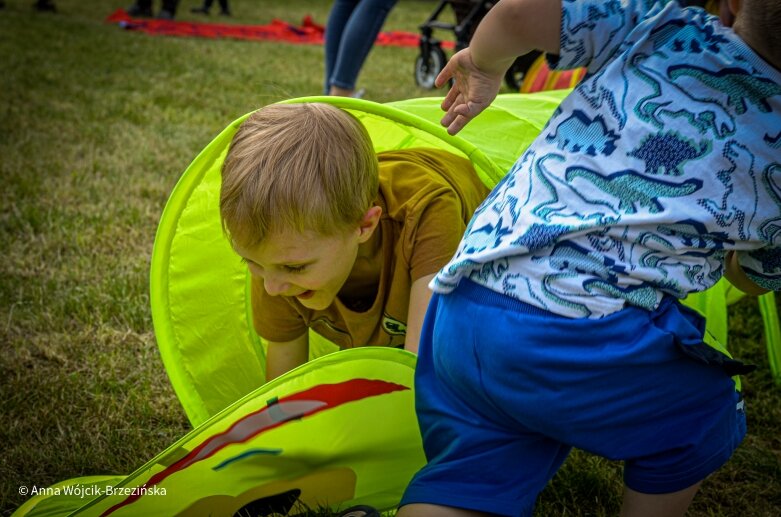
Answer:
[{"left": 220, "top": 103, "right": 379, "bottom": 247}]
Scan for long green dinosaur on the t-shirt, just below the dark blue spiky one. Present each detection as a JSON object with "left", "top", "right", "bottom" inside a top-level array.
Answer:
[{"left": 566, "top": 167, "right": 702, "bottom": 214}]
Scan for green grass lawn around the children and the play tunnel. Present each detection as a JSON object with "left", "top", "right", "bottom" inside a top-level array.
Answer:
[{"left": 0, "top": 0, "right": 781, "bottom": 516}]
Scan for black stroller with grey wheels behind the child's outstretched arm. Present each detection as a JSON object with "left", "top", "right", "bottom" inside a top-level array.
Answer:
[{"left": 415, "top": 0, "right": 541, "bottom": 92}]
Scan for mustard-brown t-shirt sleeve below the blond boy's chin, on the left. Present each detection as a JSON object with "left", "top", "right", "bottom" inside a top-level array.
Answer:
[{"left": 251, "top": 276, "right": 307, "bottom": 342}]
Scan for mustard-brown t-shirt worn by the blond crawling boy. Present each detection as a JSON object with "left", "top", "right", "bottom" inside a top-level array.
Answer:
[{"left": 252, "top": 148, "right": 488, "bottom": 348}]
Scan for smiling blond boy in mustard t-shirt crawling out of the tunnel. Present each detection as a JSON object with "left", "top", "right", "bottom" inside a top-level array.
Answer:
[{"left": 220, "top": 103, "right": 488, "bottom": 380}]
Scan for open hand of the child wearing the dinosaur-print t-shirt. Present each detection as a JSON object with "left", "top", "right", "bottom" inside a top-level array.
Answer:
[{"left": 434, "top": 48, "right": 504, "bottom": 135}]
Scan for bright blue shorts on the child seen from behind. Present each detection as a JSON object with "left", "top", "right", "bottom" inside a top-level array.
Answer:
[{"left": 401, "top": 280, "right": 746, "bottom": 515}]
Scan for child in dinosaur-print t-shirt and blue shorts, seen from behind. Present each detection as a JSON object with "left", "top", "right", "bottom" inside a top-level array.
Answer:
[{"left": 398, "top": 0, "right": 781, "bottom": 517}]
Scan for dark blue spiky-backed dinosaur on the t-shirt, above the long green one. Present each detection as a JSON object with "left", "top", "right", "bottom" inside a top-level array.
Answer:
[{"left": 629, "top": 131, "right": 711, "bottom": 176}]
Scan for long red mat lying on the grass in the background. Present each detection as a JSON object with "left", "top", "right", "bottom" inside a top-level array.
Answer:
[{"left": 106, "top": 9, "right": 454, "bottom": 48}]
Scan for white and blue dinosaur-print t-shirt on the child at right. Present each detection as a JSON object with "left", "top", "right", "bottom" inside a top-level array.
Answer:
[{"left": 431, "top": 0, "right": 781, "bottom": 318}]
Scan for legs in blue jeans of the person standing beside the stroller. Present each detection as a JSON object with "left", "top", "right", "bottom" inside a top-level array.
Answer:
[{"left": 325, "top": 0, "right": 397, "bottom": 97}]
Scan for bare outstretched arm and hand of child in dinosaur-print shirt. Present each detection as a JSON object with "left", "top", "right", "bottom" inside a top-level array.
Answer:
[{"left": 435, "top": 0, "right": 561, "bottom": 135}]
